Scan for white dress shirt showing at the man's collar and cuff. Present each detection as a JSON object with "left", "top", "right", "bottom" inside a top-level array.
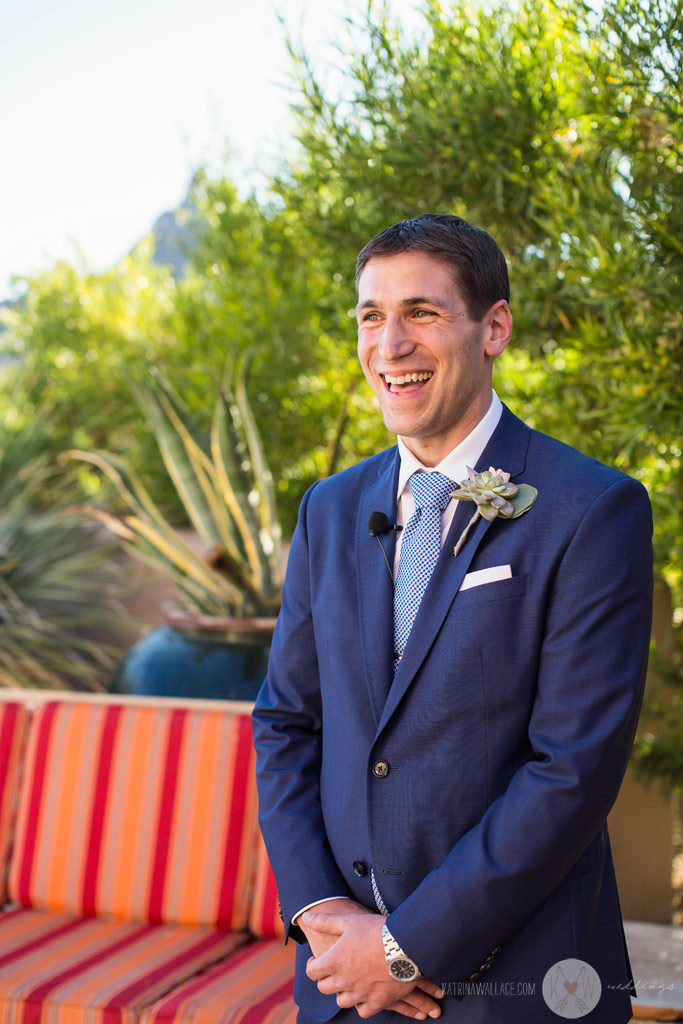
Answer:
[{"left": 292, "top": 390, "right": 503, "bottom": 925}]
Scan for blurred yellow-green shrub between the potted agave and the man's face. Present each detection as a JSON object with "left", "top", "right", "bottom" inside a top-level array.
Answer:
[{"left": 175, "top": 174, "right": 385, "bottom": 531}]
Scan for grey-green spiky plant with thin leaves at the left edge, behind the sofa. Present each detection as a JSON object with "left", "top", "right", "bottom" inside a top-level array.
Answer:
[{"left": 0, "top": 407, "right": 118, "bottom": 689}]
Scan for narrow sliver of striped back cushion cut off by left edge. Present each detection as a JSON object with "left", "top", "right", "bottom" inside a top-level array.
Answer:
[{"left": 0, "top": 700, "right": 31, "bottom": 904}]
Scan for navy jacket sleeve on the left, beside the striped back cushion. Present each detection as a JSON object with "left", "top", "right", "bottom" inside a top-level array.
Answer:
[{"left": 252, "top": 484, "right": 353, "bottom": 941}]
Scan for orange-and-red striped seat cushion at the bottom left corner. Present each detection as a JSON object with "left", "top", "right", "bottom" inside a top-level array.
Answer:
[{"left": 0, "top": 910, "right": 246, "bottom": 1024}]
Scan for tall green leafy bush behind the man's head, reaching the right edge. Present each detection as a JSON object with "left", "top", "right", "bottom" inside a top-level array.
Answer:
[{"left": 276, "top": 0, "right": 683, "bottom": 781}]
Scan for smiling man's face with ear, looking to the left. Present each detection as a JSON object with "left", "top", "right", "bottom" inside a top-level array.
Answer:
[{"left": 357, "top": 252, "right": 512, "bottom": 466}]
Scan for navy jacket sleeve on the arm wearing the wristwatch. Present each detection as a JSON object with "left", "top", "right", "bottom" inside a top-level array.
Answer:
[{"left": 387, "top": 478, "right": 652, "bottom": 980}]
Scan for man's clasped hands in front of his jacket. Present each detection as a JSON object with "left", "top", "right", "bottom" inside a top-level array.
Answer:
[{"left": 297, "top": 900, "right": 443, "bottom": 1020}]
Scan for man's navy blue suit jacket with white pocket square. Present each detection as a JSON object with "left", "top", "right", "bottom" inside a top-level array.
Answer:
[{"left": 254, "top": 409, "right": 652, "bottom": 1024}]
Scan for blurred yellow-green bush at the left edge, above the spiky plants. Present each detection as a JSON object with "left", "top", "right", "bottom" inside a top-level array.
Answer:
[{"left": 0, "top": 240, "right": 181, "bottom": 512}]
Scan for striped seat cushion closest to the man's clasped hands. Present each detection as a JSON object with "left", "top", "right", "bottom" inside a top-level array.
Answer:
[{"left": 140, "top": 939, "right": 297, "bottom": 1024}]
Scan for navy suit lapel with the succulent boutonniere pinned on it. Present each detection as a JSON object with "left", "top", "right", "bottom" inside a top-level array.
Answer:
[{"left": 377, "top": 406, "right": 530, "bottom": 734}]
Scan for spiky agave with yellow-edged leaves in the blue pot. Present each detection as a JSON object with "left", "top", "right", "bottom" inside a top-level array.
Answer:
[{"left": 68, "top": 370, "right": 282, "bottom": 617}]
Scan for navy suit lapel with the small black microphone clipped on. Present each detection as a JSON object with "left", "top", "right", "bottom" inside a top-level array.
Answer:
[{"left": 355, "top": 449, "right": 400, "bottom": 725}]
